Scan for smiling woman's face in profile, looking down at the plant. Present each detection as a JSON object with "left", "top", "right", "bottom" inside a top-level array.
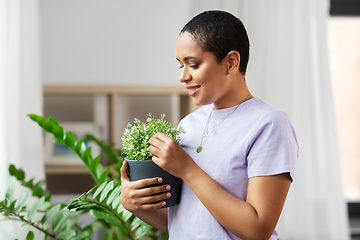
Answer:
[{"left": 176, "top": 32, "right": 231, "bottom": 108}]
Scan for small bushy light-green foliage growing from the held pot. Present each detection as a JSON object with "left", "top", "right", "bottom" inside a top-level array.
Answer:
[{"left": 121, "top": 113, "right": 185, "bottom": 160}]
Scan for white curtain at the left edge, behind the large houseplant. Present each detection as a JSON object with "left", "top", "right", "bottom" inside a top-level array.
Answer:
[{"left": 0, "top": 0, "right": 45, "bottom": 239}]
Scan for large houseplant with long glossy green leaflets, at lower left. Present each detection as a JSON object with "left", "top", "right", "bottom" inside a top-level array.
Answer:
[{"left": 0, "top": 114, "right": 167, "bottom": 240}]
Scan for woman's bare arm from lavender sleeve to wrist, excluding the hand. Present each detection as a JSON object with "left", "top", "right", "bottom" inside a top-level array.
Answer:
[{"left": 184, "top": 165, "right": 291, "bottom": 240}]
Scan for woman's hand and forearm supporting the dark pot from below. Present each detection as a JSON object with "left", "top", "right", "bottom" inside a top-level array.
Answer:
[{"left": 120, "top": 161, "right": 170, "bottom": 232}]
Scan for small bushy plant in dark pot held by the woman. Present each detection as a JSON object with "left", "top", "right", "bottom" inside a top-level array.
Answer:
[{"left": 121, "top": 113, "right": 185, "bottom": 207}]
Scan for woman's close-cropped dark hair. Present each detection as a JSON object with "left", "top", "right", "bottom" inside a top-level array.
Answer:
[{"left": 180, "top": 10, "right": 250, "bottom": 74}]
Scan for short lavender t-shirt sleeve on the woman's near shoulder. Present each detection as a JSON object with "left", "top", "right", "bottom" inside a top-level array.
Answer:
[{"left": 247, "top": 110, "right": 299, "bottom": 179}]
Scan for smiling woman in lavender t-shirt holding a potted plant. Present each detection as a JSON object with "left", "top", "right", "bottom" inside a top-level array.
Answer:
[{"left": 121, "top": 11, "right": 298, "bottom": 240}]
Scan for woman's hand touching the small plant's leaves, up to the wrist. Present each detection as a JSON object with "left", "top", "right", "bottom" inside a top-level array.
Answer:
[{"left": 149, "top": 132, "right": 195, "bottom": 178}]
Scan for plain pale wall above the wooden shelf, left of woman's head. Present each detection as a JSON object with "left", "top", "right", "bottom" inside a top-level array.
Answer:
[{"left": 40, "top": 0, "right": 191, "bottom": 85}]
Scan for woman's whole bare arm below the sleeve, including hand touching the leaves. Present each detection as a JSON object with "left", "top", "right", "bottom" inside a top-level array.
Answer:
[{"left": 149, "top": 133, "right": 291, "bottom": 240}]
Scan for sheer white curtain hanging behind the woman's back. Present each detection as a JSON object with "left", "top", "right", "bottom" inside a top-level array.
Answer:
[{"left": 192, "top": 0, "right": 350, "bottom": 240}]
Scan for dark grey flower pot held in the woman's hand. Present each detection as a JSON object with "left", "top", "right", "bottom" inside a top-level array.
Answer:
[{"left": 125, "top": 158, "right": 182, "bottom": 208}]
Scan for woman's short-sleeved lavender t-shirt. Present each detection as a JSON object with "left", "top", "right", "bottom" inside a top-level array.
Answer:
[{"left": 168, "top": 98, "right": 298, "bottom": 240}]
